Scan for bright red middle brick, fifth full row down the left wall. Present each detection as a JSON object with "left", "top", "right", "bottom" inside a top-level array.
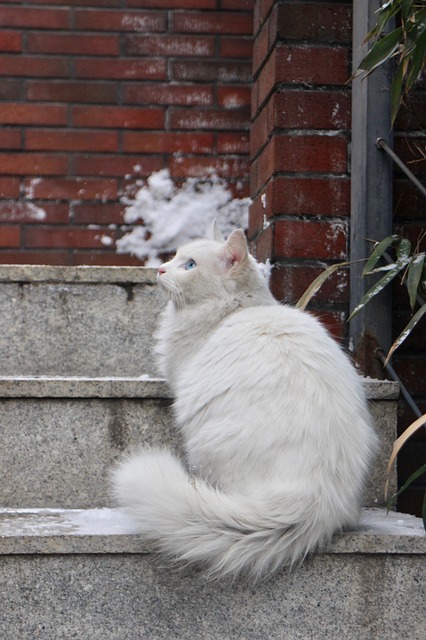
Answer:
[{"left": 72, "top": 107, "right": 164, "bottom": 129}]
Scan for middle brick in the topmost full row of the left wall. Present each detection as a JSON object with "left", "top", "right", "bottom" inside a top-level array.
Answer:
[{"left": 75, "top": 5, "right": 167, "bottom": 33}]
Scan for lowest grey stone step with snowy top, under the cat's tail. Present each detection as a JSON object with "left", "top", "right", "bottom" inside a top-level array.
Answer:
[{"left": 0, "top": 509, "right": 426, "bottom": 640}]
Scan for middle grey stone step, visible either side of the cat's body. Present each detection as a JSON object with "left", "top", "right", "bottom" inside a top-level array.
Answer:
[{"left": 0, "top": 376, "right": 398, "bottom": 508}]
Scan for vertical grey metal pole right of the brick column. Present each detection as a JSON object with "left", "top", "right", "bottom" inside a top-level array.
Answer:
[{"left": 349, "top": 0, "right": 392, "bottom": 377}]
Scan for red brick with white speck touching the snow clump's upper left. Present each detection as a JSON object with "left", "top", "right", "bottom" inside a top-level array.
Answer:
[{"left": 73, "top": 154, "right": 164, "bottom": 177}]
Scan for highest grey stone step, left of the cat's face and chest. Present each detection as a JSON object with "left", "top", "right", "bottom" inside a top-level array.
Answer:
[{"left": 0, "top": 265, "right": 165, "bottom": 376}]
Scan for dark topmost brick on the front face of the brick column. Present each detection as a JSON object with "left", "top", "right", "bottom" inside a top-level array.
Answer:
[{"left": 277, "top": 2, "right": 352, "bottom": 43}]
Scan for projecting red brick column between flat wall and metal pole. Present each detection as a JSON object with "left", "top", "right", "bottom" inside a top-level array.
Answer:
[{"left": 249, "top": 0, "right": 351, "bottom": 336}]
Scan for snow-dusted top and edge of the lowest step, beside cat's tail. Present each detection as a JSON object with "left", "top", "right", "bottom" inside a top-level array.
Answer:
[{"left": 0, "top": 508, "right": 426, "bottom": 555}]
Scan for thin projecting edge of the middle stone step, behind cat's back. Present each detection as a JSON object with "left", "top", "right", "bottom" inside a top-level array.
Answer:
[{"left": 0, "top": 374, "right": 399, "bottom": 400}]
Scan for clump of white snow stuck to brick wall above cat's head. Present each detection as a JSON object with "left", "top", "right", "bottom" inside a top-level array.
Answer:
[{"left": 116, "top": 169, "right": 251, "bottom": 267}]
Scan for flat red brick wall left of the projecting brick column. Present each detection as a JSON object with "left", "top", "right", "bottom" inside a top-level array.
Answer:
[{"left": 0, "top": 0, "right": 253, "bottom": 264}]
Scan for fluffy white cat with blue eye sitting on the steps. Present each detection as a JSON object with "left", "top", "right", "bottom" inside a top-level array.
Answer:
[{"left": 113, "top": 225, "right": 376, "bottom": 580}]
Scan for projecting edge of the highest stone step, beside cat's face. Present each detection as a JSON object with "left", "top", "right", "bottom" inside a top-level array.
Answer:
[{"left": 0, "top": 264, "right": 157, "bottom": 285}]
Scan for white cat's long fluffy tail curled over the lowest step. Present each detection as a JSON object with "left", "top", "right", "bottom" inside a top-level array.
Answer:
[{"left": 113, "top": 450, "right": 346, "bottom": 580}]
